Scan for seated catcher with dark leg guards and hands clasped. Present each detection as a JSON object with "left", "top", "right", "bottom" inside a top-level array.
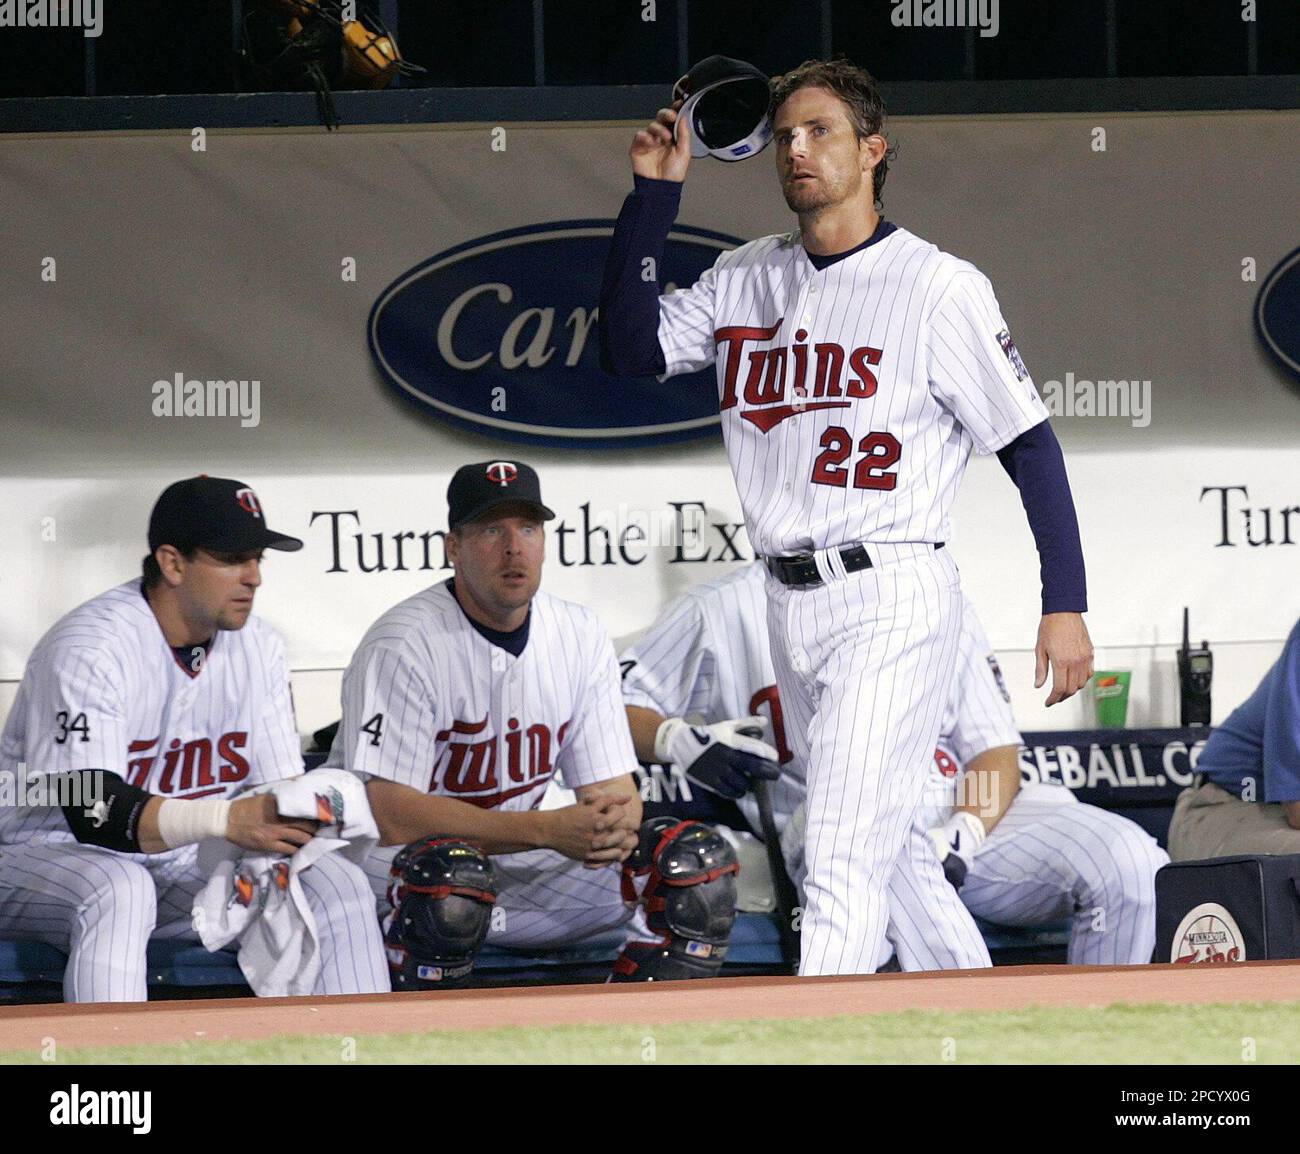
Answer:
[{"left": 328, "top": 461, "right": 737, "bottom": 989}]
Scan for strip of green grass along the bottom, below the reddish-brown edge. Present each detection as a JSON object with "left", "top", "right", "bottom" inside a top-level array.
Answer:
[{"left": 0, "top": 1002, "right": 1300, "bottom": 1064}]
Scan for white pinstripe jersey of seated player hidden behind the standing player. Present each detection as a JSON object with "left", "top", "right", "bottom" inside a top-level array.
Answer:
[{"left": 621, "top": 561, "right": 1021, "bottom": 828}]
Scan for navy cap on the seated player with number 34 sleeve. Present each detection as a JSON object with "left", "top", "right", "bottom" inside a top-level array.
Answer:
[{"left": 150, "top": 474, "right": 303, "bottom": 552}]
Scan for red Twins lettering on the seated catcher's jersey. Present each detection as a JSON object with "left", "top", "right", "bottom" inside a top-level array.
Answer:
[{"left": 429, "top": 715, "right": 569, "bottom": 807}]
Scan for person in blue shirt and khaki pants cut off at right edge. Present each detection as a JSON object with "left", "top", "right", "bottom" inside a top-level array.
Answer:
[{"left": 1169, "top": 621, "right": 1300, "bottom": 862}]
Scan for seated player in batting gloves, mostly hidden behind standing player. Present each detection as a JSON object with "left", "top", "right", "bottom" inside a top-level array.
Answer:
[{"left": 621, "top": 563, "right": 1167, "bottom": 969}]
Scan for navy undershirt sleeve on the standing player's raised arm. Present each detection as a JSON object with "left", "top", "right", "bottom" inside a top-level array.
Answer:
[{"left": 597, "top": 177, "right": 681, "bottom": 377}]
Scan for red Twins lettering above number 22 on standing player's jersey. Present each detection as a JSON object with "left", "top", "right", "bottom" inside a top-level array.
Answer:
[{"left": 714, "top": 318, "right": 881, "bottom": 433}]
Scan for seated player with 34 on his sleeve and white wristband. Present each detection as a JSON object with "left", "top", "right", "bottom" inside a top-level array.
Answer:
[{"left": 0, "top": 477, "right": 389, "bottom": 1002}]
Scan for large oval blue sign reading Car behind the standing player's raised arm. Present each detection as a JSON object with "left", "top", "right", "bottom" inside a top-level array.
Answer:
[{"left": 369, "top": 220, "right": 744, "bottom": 448}]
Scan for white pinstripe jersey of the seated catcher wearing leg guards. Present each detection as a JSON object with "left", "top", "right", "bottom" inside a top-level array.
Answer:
[{"left": 328, "top": 582, "right": 637, "bottom": 811}]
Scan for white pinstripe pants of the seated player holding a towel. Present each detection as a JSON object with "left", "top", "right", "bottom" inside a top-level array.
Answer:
[{"left": 0, "top": 842, "right": 389, "bottom": 1002}]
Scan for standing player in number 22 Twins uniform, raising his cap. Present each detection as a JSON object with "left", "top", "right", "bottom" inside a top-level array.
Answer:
[{"left": 601, "top": 61, "right": 1092, "bottom": 973}]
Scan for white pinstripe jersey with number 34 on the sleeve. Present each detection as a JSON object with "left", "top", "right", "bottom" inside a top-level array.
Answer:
[{"left": 0, "top": 580, "right": 303, "bottom": 843}]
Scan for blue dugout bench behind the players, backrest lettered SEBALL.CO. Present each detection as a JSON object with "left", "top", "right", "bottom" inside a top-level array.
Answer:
[{"left": 0, "top": 728, "right": 1209, "bottom": 1002}]
